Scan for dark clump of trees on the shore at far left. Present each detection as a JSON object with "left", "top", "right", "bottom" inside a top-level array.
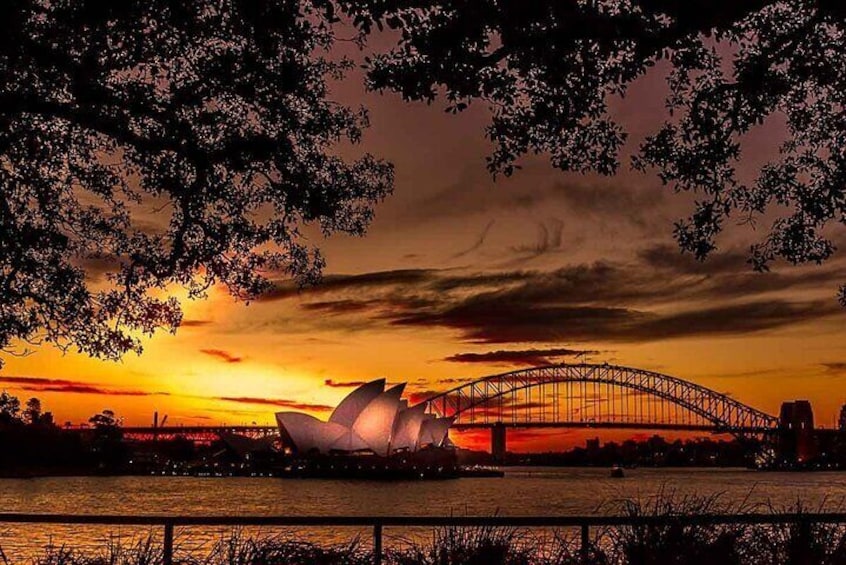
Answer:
[{"left": 0, "top": 391, "right": 128, "bottom": 476}]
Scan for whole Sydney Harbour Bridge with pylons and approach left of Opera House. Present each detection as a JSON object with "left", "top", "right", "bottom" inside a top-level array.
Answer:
[{"left": 124, "top": 363, "right": 813, "bottom": 458}]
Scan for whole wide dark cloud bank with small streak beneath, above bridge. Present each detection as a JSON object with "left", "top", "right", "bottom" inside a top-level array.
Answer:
[{"left": 258, "top": 245, "right": 844, "bottom": 346}]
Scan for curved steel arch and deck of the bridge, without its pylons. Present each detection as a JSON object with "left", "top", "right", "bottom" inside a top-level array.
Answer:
[{"left": 425, "top": 363, "right": 778, "bottom": 438}]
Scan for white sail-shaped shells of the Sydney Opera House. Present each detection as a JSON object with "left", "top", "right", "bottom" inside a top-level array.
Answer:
[{"left": 276, "top": 379, "right": 452, "bottom": 457}]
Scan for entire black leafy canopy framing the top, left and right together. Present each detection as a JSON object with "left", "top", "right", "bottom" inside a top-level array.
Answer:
[{"left": 0, "top": 0, "right": 846, "bottom": 366}]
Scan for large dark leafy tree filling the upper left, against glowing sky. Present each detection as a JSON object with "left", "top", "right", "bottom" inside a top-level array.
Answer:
[{"left": 0, "top": 0, "right": 393, "bottom": 364}]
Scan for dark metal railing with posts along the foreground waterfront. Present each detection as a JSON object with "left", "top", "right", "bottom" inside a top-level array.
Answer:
[{"left": 0, "top": 512, "right": 846, "bottom": 565}]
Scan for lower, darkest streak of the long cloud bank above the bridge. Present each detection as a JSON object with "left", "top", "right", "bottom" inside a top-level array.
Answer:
[{"left": 294, "top": 282, "right": 841, "bottom": 344}]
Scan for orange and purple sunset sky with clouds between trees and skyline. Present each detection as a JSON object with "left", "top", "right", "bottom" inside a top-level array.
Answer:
[{"left": 0, "top": 39, "right": 846, "bottom": 449}]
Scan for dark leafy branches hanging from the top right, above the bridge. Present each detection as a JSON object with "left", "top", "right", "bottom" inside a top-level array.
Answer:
[{"left": 340, "top": 0, "right": 846, "bottom": 305}]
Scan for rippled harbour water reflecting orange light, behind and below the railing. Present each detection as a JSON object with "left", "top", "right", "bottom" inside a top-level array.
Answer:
[{"left": 0, "top": 467, "right": 846, "bottom": 563}]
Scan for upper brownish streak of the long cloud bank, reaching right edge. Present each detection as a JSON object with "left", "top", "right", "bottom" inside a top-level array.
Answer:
[{"left": 260, "top": 251, "right": 846, "bottom": 317}]
